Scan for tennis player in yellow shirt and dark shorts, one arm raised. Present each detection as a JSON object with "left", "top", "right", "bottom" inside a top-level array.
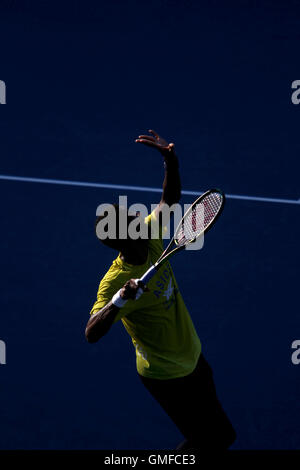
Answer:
[{"left": 85, "top": 130, "right": 236, "bottom": 451}]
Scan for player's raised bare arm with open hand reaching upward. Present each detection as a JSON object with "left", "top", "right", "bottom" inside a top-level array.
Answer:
[{"left": 135, "top": 130, "right": 181, "bottom": 215}]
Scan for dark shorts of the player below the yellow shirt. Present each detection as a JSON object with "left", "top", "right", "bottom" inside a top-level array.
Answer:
[{"left": 139, "top": 354, "right": 236, "bottom": 450}]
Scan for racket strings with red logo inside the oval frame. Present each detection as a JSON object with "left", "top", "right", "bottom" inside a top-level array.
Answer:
[{"left": 175, "top": 192, "right": 222, "bottom": 245}]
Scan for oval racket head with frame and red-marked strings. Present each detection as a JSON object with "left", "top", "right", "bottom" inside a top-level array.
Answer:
[{"left": 174, "top": 188, "right": 225, "bottom": 247}]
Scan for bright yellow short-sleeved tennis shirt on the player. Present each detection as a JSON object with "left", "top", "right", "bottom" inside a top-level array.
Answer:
[{"left": 90, "top": 213, "right": 201, "bottom": 379}]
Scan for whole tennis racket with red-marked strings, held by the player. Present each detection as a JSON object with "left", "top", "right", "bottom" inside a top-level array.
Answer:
[{"left": 139, "top": 189, "right": 225, "bottom": 284}]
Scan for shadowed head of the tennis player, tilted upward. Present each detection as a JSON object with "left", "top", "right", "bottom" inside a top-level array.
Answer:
[{"left": 95, "top": 204, "right": 146, "bottom": 251}]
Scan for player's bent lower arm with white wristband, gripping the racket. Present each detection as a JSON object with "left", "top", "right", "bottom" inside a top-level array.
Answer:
[{"left": 85, "top": 279, "right": 149, "bottom": 343}]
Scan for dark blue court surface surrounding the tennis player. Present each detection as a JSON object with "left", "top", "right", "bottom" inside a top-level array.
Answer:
[{"left": 0, "top": 0, "right": 300, "bottom": 449}]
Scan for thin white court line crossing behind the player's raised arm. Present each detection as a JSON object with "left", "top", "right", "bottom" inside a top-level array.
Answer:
[{"left": 0, "top": 175, "right": 300, "bottom": 205}]
